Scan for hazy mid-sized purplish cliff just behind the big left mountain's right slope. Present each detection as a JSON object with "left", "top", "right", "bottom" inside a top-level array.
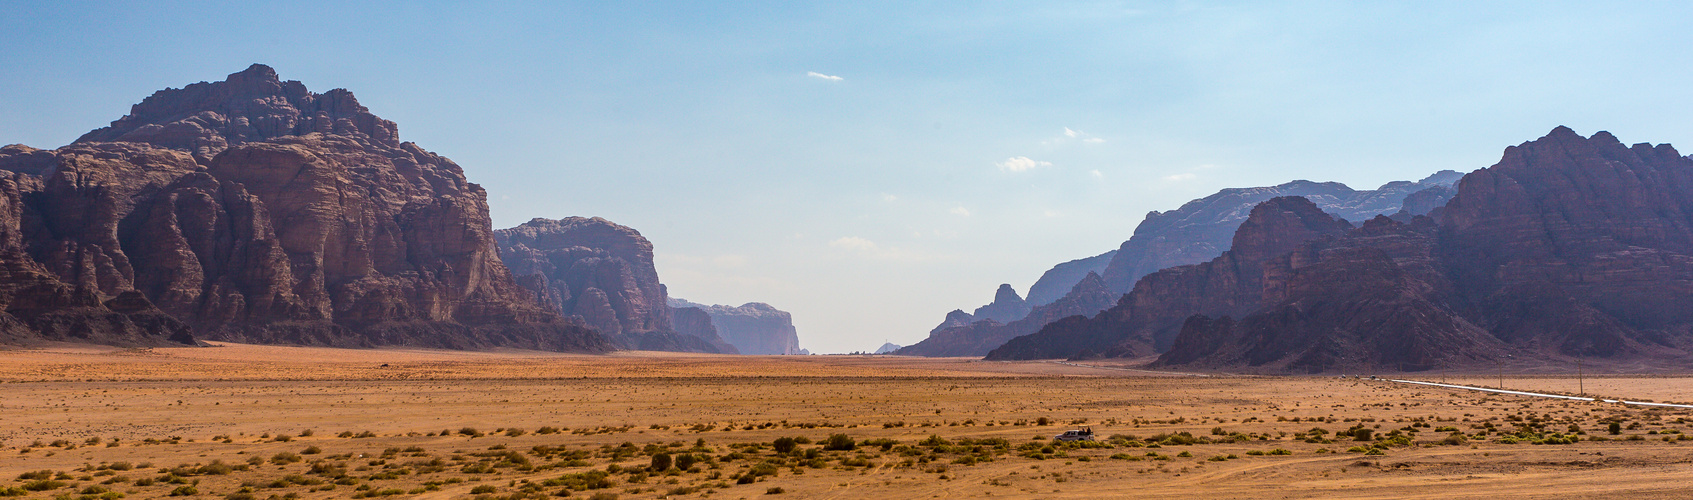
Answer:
[{"left": 494, "top": 217, "right": 723, "bottom": 353}]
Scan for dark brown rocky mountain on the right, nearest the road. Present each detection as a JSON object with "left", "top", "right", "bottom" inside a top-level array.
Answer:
[{"left": 989, "top": 127, "right": 1693, "bottom": 371}]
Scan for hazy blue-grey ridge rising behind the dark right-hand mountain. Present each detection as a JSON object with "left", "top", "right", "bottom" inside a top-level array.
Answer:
[{"left": 902, "top": 169, "right": 1463, "bottom": 356}]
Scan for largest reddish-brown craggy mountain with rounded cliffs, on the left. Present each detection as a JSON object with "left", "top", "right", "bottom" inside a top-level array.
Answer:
[{"left": 0, "top": 64, "right": 611, "bottom": 353}]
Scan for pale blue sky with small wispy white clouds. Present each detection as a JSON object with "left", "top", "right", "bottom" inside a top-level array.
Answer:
[{"left": 0, "top": 0, "right": 1693, "bottom": 353}]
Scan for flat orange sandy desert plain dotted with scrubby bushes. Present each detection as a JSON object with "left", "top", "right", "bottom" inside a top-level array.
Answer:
[{"left": 0, "top": 344, "right": 1693, "bottom": 498}]
